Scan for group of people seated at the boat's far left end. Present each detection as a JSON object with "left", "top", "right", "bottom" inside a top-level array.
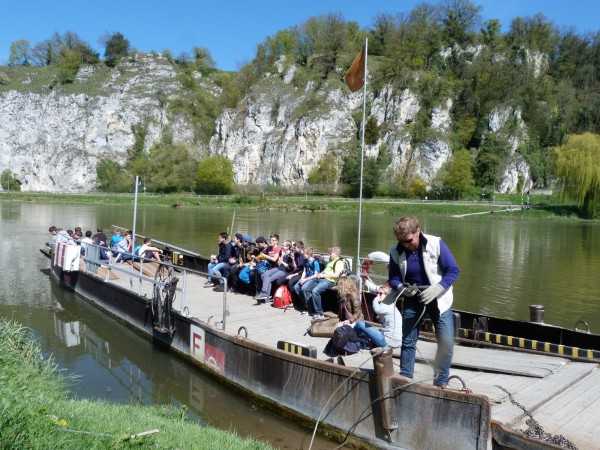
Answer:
[{"left": 48, "top": 225, "right": 163, "bottom": 262}]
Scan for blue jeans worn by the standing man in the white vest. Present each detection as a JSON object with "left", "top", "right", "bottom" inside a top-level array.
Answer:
[{"left": 400, "top": 298, "right": 454, "bottom": 386}]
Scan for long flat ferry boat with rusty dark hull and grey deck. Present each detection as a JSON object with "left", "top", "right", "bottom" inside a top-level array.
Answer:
[{"left": 41, "top": 234, "right": 600, "bottom": 449}]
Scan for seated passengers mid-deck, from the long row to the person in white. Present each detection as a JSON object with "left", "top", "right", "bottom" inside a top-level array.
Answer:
[{"left": 205, "top": 233, "right": 402, "bottom": 347}]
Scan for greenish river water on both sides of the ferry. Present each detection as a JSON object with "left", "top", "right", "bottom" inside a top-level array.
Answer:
[{"left": 0, "top": 202, "right": 600, "bottom": 448}]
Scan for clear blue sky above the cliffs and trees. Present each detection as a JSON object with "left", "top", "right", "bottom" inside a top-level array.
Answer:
[{"left": 0, "top": 0, "right": 600, "bottom": 70}]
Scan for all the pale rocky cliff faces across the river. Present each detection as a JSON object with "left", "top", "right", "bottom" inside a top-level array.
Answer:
[{"left": 0, "top": 55, "right": 531, "bottom": 192}]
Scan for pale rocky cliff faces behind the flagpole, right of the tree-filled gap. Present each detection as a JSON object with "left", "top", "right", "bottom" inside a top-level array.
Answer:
[{"left": 210, "top": 59, "right": 531, "bottom": 192}]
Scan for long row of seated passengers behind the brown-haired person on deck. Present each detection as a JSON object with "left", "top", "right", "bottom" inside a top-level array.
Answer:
[{"left": 205, "top": 232, "right": 352, "bottom": 318}]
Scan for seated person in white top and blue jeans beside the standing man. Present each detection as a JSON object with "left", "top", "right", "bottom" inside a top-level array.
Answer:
[{"left": 354, "top": 288, "right": 402, "bottom": 348}]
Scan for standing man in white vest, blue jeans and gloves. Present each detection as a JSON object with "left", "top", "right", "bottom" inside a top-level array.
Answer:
[{"left": 389, "top": 217, "right": 460, "bottom": 387}]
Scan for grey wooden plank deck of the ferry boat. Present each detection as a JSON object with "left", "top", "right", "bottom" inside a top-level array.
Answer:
[{"left": 105, "top": 264, "right": 600, "bottom": 449}]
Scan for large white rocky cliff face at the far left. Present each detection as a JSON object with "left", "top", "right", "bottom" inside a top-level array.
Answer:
[{"left": 0, "top": 56, "right": 191, "bottom": 192}]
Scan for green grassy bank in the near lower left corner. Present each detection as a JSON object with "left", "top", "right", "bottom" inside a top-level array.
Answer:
[{"left": 0, "top": 319, "right": 271, "bottom": 449}]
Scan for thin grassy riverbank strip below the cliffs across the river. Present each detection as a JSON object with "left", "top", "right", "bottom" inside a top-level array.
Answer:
[{"left": 0, "top": 192, "right": 585, "bottom": 220}]
